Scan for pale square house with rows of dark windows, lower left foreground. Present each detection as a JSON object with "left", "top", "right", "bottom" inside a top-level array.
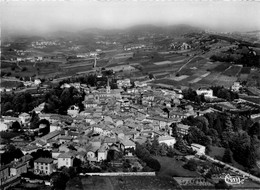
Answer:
[{"left": 34, "top": 158, "right": 53, "bottom": 175}]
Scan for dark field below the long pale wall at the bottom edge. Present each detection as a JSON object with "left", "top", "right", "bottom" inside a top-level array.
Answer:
[{"left": 66, "top": 176, "right": 180, "bottom": 190}]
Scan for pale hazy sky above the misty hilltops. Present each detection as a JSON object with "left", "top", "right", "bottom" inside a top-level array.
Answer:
[{"left": 1, "top": 0, "right": 260, "bottom": 31}]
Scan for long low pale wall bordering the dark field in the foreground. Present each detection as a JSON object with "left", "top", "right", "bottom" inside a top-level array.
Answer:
[{"left": 80, "top": 172, "right": 155, "bottom": 176}]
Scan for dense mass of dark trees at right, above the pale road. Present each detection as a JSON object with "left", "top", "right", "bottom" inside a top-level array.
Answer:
[{"left": 176, "top": 112, "right": 260, "bottom": 169}]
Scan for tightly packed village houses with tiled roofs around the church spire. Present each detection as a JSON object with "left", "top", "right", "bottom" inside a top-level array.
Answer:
[{"left": 0, "top": 79, "right": 260, "bottom": 189}]
